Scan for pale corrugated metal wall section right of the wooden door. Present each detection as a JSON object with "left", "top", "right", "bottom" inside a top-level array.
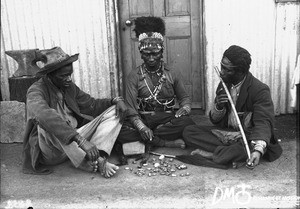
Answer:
[{"left": 204, "top": 0, "right": 300, "bottom": 114}]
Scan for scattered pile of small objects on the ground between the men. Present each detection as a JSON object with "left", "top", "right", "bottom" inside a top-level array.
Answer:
[{"left": 125, "top": 155, "right": 190, "bottom": 177}]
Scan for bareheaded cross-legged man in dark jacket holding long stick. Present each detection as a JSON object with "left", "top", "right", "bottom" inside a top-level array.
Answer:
[{"left": 183, "top": 45, "right": 282, "bottom": 166}]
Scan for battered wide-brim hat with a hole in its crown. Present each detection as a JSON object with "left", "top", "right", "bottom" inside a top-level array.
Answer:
[{"left": 36, "top": 47, "right": 79, "bottom": 76}]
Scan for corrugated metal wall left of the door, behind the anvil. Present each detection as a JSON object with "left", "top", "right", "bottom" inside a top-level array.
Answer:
[{"left": 1, "top": 0, "right": 118, "bottom": 100}]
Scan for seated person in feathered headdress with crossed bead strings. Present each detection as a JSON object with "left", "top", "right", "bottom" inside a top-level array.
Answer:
[{"left": 118, "top": 17, "right": 194, "bottom": 158}]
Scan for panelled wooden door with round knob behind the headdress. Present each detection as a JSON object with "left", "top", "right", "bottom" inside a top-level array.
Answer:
[{"left": 118, "top": 0, "right": 204, "bottom": 108}]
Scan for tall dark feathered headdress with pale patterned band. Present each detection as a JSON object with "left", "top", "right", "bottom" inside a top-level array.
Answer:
[{"left": 134, "top": 16, "right": 165, "bottom": 51}]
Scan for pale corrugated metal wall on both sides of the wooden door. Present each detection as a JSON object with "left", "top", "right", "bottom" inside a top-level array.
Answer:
[{"left": 1, "top": 0, "right": 300, "bottom": 114}]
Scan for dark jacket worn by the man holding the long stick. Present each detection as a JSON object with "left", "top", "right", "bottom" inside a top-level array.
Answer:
[{"left": 210, "top": 72, "right": 282, "bottom": 161}]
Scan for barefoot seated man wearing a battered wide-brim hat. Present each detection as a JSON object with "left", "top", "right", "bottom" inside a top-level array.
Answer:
[{"left": 23, "top": 47, "right": 127, "bottom": 177}]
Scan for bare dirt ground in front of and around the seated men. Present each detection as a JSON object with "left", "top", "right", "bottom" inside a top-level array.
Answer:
[{"left": 0, "top": 114, "right": 299, "bottom": 209}]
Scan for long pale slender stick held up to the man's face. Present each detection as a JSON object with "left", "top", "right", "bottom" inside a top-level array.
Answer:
[{"left": 214, "top": 66, "right": 250, "bottom": 160}]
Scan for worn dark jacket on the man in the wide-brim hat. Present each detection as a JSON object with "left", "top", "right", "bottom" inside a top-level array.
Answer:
[{"left": 23, "top": 77, "right": 112, "bottom": 174}]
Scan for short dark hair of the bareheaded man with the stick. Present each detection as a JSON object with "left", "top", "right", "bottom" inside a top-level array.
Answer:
[{"left": 223, "top": 45, "right": 251, "bottom": 74}]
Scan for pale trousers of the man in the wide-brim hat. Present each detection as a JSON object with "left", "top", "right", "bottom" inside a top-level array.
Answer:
[{"left": 38, "top": 106, "right": 122, "bottom": 168}]
